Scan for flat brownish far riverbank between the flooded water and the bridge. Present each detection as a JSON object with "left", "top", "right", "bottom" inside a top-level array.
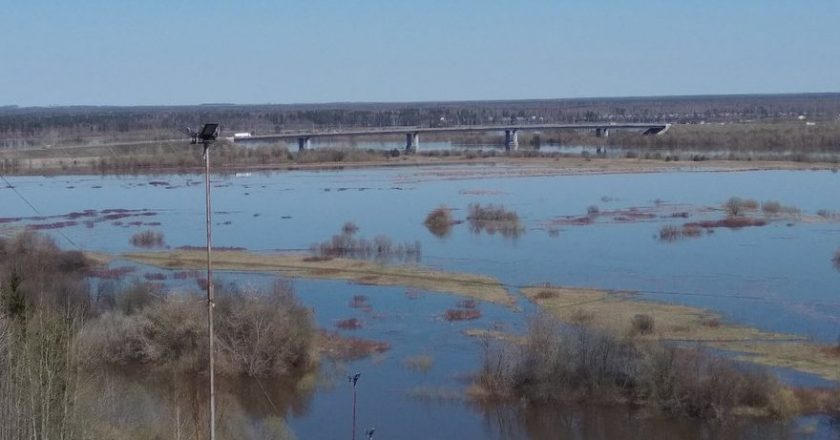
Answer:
[{"left": 0, "top": 146, "right": 838, "bottom": 177}]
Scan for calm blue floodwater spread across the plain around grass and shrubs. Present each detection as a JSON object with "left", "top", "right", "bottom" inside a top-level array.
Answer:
[{"left": 0, "top": 165, "right": 840, "bottom": 439}]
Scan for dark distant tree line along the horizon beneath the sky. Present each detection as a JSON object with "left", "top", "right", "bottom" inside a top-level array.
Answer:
[{"left": 0, "top": 94, "right": 840, "bottom": 148}]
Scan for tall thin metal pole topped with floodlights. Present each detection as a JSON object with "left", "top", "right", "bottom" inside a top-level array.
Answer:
[{"left": 190, "top": 123, "right": 219, "bottom": 440}]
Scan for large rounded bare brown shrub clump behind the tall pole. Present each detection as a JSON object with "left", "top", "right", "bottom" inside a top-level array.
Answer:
[{"left": 83, "top": 282, "right": 314, "bottom": 377}]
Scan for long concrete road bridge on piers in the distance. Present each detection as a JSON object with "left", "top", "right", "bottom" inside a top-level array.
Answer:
[{"left": 231, "top": 123, "right": 671, "bottom": 151}]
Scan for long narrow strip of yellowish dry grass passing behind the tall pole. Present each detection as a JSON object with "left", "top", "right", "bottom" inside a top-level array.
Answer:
[{"left": 124, "top": 250, "right": 514, "bottom": 305}]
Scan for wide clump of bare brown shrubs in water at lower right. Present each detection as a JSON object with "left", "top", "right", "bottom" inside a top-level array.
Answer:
[{"left": 475, "top": 317, "right": 789, "bottom": 419}]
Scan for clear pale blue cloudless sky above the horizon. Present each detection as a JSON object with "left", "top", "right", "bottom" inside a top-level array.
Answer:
[{"left": 0, "top": 0, "right": 840, "bottom": 106}]
